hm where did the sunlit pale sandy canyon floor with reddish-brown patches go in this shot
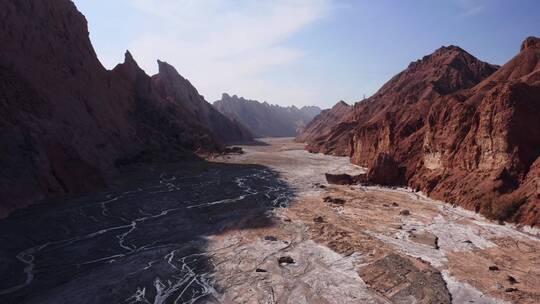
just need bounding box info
[211,139,540,303]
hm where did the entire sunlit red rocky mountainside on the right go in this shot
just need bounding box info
[309,38,540,225]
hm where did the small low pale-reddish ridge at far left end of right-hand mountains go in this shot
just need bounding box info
[296,101,352,154]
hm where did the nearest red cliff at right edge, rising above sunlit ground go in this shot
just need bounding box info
[409,38,540,225]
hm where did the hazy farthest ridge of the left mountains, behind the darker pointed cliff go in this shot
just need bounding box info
[152,61,253,142]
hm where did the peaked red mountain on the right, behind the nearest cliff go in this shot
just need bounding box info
[350,46,496,170]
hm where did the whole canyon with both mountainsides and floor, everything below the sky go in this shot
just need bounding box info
[0,0,540,304]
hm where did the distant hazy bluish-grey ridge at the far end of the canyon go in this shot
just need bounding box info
[214,94,321,137]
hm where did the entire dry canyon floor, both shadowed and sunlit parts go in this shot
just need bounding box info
[0,139,540,304]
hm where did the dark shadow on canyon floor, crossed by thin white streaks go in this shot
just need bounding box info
[0,162,294,303]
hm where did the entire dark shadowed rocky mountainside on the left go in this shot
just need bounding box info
[0,0,251,213]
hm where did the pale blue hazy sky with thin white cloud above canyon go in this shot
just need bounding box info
[74,0,540,107]
